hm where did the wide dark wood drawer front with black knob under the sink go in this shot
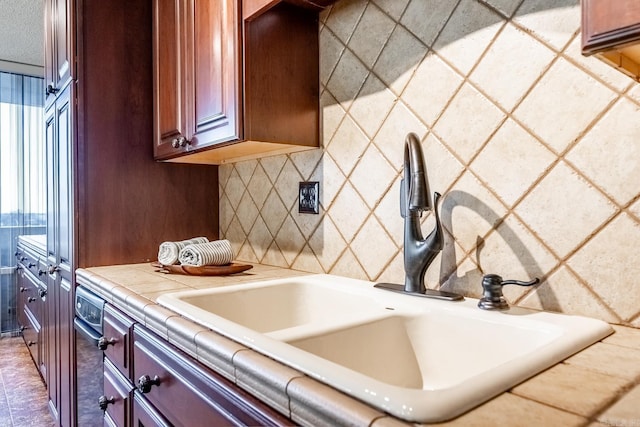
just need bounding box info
[133,325,290,427]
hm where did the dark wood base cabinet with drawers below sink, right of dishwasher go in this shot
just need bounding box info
[100,305,292,427]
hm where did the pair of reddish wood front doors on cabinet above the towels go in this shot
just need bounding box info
[153,0,241,159]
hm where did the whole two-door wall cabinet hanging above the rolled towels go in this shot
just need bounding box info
[153,0,322,164]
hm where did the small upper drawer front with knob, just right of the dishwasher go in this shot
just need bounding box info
[103,304,134,379]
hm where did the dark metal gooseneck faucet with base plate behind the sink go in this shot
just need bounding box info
[375,133,463,300]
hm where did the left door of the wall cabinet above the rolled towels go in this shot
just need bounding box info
[153,0,189,158]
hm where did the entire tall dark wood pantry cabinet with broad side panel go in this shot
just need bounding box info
[43,0,218,426]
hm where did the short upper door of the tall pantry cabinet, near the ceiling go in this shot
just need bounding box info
[44,0,75,104]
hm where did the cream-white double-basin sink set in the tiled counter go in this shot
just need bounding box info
[158,275,612,422]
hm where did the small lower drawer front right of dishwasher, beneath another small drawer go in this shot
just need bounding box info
[102,359,133,427]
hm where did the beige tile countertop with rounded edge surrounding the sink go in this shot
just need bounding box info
[77,264,640,427]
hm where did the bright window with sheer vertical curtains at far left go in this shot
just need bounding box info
[0,72,46,333]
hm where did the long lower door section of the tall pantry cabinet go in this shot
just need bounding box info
[44,85,74,426]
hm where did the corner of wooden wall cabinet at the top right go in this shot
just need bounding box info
[582,0,640,81]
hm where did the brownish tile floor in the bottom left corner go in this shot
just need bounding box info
[0,337,55,427]
